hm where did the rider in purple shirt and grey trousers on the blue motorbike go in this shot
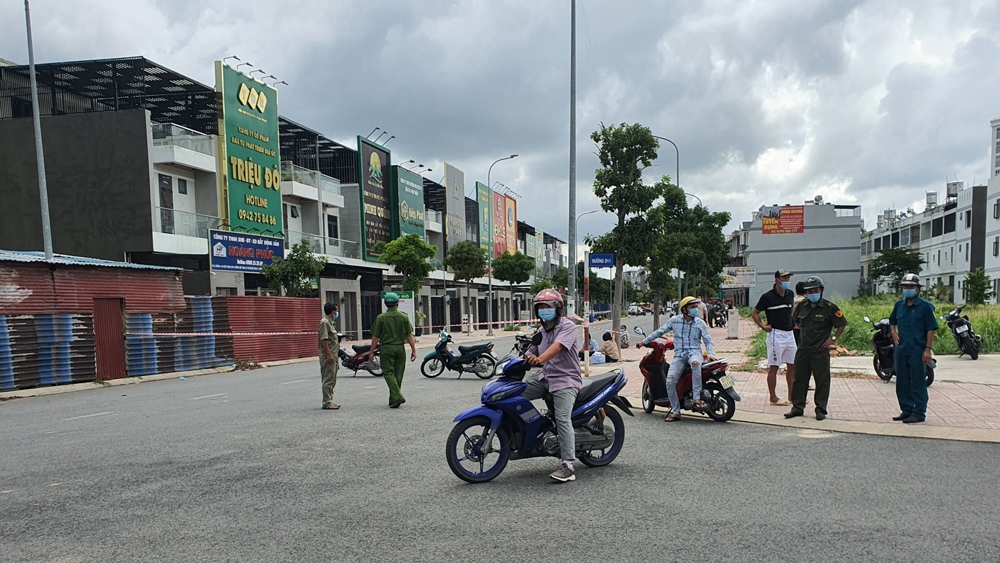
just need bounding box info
[524,289,583,483]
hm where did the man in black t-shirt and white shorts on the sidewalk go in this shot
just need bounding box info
[750,268,797,406]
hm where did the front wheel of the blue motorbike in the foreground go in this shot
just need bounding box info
[444,416,510,483]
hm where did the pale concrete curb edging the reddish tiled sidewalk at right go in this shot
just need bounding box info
[627,397,1000,444]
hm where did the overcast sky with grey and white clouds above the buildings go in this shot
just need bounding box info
[0,0,1000,251]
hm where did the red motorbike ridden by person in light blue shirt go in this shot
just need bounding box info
[635,327,741,422]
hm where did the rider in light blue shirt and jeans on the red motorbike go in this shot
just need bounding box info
[635,297,715,422]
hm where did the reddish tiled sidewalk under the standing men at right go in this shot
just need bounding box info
[621,322,1000,434]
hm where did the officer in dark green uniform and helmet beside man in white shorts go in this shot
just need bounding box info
[785,276,847,420]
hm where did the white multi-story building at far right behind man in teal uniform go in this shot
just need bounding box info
[861,182,987,303]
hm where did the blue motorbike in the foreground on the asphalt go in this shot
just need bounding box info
[445,358,634,483]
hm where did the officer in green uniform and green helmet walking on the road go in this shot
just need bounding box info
[372,293,417,409]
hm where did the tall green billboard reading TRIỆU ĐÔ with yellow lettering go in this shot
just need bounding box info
[215,61,284,237]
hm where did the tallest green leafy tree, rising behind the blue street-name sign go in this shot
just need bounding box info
[588,123,667,334]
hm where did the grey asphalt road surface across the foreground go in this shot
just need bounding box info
[0,330,1000,562]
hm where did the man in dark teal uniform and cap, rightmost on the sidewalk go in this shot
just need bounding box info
[889,274,938,424]
